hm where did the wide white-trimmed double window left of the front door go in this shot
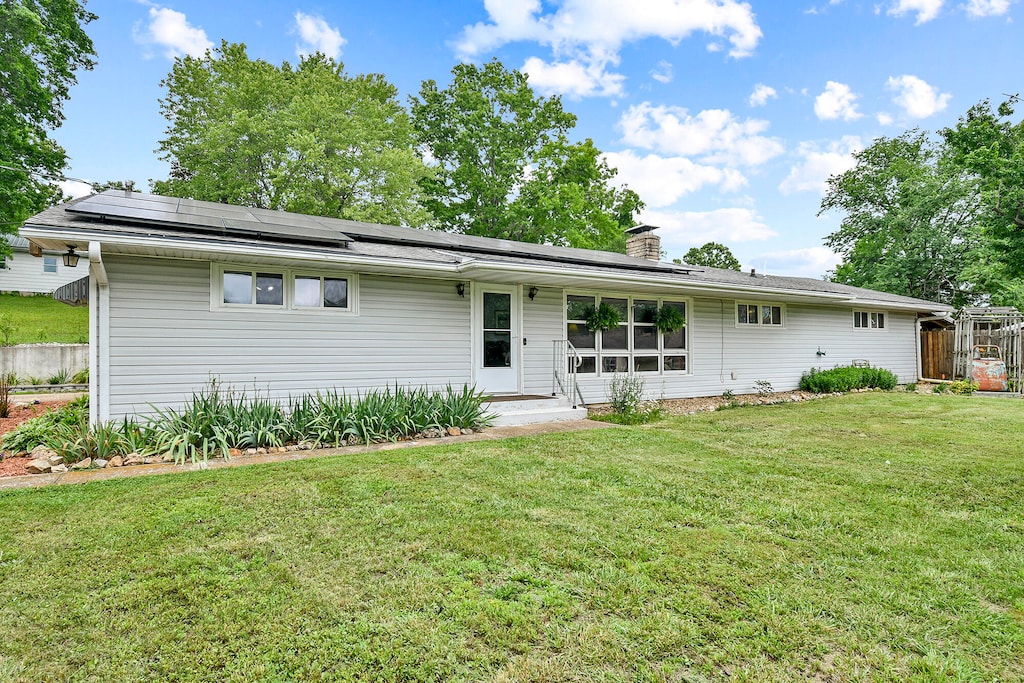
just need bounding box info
[210,265,355,312]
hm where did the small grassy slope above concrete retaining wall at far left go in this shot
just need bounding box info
[0,294,89,344]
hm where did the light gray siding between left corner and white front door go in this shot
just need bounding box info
[104,256,471,418]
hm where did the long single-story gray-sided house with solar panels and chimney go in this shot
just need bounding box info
[23,190,950,420]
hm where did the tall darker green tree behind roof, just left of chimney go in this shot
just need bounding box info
[411,59,643,251]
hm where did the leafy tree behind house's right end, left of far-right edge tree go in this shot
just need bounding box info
[819,130,982,306]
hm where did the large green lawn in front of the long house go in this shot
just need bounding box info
[0,393,1024,681]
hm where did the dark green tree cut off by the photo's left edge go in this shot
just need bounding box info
[0,0,96,258]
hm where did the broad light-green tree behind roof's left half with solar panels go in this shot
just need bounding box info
[154,42,430,225]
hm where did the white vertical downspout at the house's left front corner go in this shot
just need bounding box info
[89,242,111,425]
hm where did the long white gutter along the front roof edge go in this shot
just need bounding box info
[20,225,941,311]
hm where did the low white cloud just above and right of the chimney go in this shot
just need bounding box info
[640,208,778,256]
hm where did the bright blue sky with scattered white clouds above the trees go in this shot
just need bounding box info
[54,0,1022,278]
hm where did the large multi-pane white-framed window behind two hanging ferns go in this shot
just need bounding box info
[565,294,689,375]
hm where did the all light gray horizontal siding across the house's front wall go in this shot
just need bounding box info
[104,256,918,419]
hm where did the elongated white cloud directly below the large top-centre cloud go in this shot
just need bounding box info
[618,102,783,166]
